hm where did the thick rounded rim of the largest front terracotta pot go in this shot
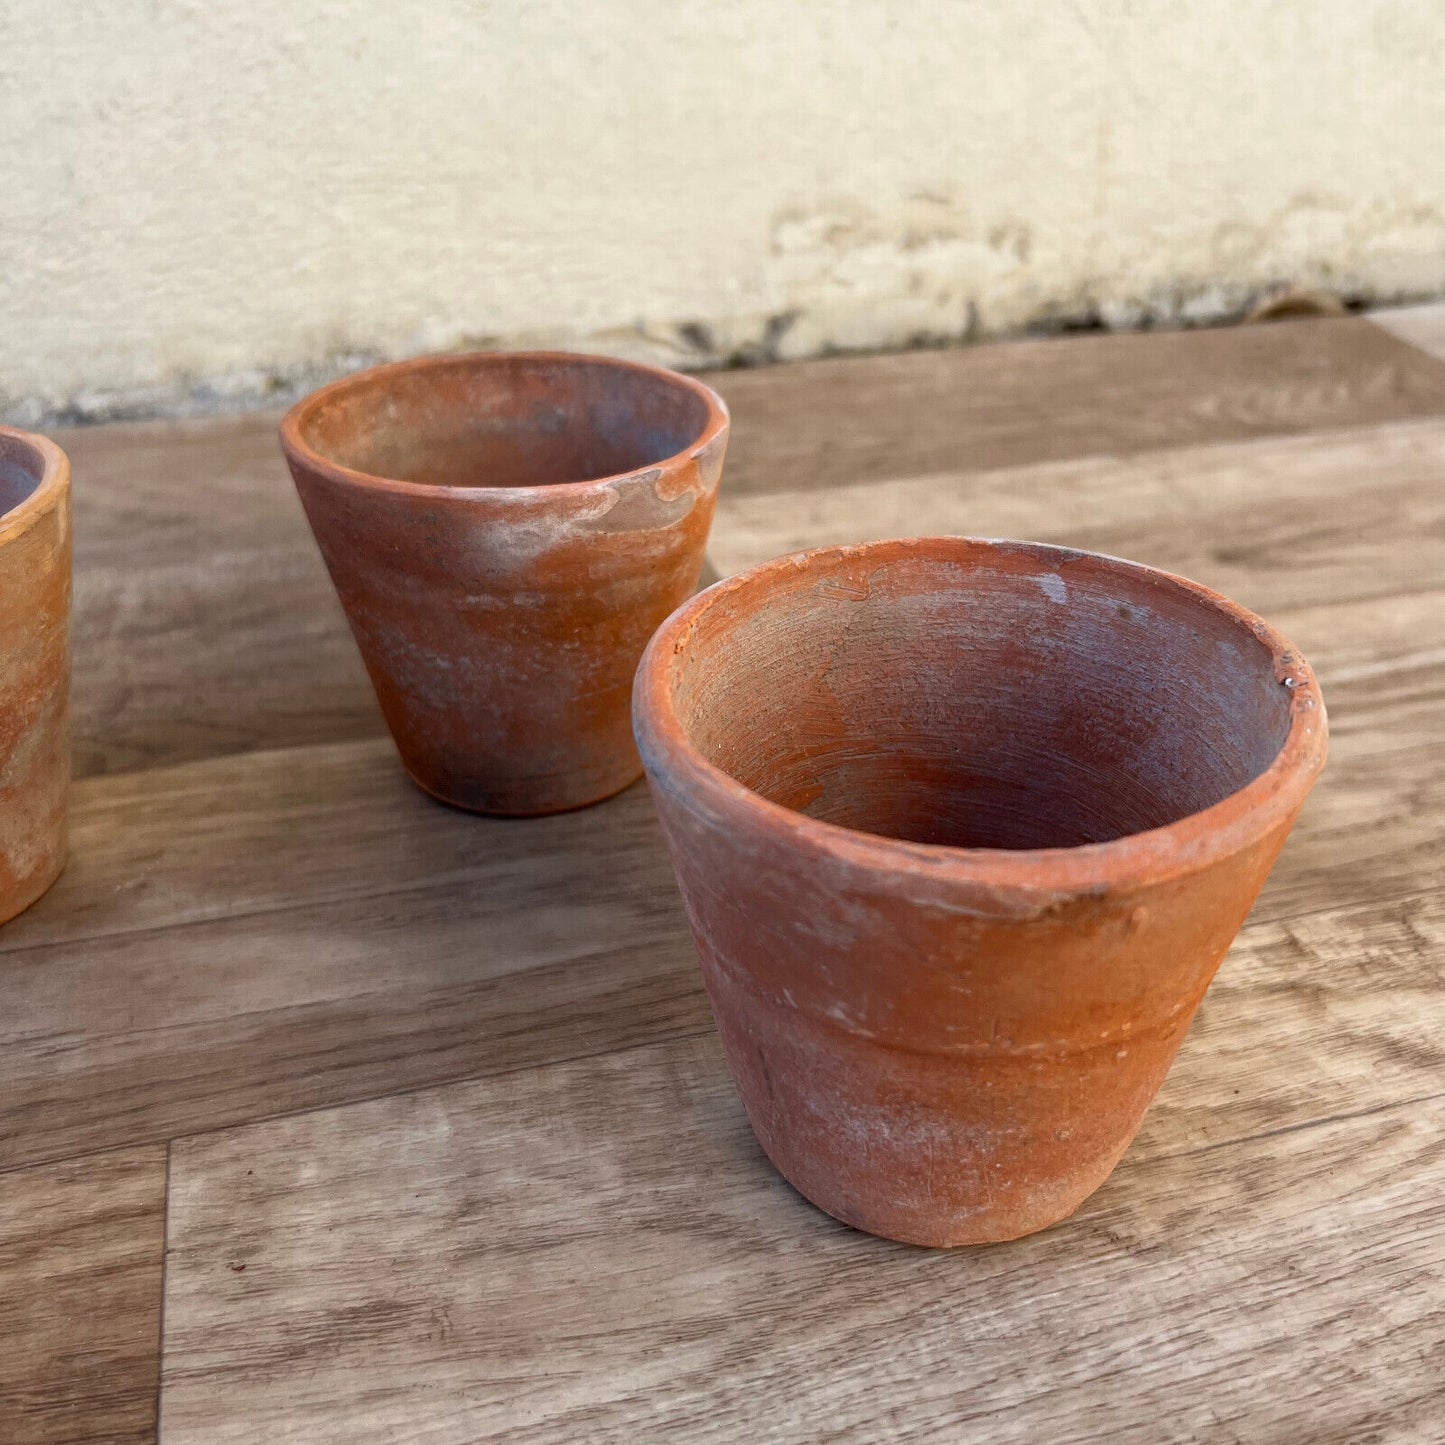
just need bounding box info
[633,536,1328,916]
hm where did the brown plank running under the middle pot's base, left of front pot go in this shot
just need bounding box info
[0,738,660,957]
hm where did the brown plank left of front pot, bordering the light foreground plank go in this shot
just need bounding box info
[0,849,711,1168]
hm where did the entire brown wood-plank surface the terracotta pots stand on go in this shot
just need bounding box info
[0,308,1445,1445]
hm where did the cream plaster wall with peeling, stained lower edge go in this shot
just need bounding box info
[0,0,1445,419]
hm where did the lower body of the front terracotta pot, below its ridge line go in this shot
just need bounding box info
[704,976,1173,1248]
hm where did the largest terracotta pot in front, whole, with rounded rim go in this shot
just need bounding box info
[634,538,1325,1244]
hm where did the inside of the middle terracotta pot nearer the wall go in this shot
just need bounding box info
[301,354,709,487]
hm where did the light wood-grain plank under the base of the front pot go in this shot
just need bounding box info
[163,1038,1445,1445]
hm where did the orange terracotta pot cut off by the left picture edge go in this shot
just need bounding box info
[0,426,71,923]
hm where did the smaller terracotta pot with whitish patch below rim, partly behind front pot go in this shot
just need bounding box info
[282,353,728,814]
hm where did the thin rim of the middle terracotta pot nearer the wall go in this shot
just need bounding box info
[280,351,730,500]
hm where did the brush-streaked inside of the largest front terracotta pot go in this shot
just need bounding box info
[669,539,1290,848]
